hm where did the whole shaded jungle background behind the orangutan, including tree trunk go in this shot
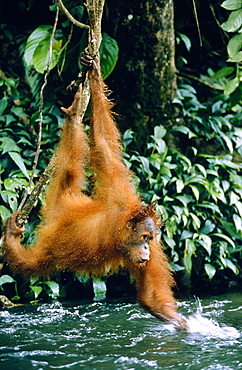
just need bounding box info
[0,0,242,301]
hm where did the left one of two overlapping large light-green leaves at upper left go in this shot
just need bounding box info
[24,25,51,66]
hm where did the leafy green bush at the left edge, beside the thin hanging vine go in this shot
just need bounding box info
[0,69,61,227]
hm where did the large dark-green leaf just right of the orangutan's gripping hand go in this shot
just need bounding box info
[99,33,119,80]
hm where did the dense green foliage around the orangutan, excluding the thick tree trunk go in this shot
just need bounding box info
[0,0,242,299]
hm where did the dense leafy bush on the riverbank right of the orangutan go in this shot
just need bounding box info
[124,85,242,285]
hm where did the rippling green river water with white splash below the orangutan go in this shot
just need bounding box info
[0,293,242,370]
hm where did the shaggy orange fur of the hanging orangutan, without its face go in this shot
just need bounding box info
[4,56,183,325]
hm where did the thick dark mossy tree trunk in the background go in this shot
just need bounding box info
[104,0,177,139]
